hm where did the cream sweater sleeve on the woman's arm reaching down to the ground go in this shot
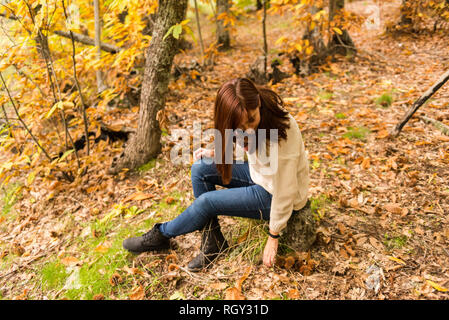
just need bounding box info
[270,155,299,232]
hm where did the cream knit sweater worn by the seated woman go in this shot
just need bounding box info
[236,114,309,232]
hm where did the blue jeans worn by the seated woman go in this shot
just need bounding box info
[159,158,272,238]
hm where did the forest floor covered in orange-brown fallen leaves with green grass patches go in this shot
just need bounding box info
[0,2,449,299]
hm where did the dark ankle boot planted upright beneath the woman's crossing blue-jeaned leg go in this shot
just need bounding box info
[187,218,229,272]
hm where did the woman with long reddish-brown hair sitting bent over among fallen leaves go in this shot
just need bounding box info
[123,78,309,271]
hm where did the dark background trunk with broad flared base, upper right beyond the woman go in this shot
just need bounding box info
[328,0,356,55]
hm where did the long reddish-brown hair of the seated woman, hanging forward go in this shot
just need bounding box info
[214,78,289,184]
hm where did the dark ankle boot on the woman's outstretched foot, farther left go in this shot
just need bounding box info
[123,223,170,254]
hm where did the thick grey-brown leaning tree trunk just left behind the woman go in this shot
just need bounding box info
[108,0,188,174]
